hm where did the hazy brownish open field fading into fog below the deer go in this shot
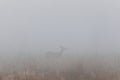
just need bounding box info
[0,53,120,80]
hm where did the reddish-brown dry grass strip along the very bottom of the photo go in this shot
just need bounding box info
[0,64,120,80]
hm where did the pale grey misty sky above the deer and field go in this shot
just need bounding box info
[0,0,120,53]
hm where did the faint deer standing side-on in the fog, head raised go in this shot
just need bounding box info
[45,46,66,58]
